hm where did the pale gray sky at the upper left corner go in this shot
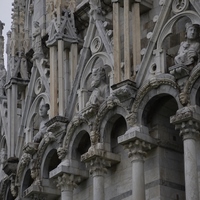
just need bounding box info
[0,0,13,68]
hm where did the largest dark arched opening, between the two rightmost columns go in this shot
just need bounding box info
[142,94,185,199]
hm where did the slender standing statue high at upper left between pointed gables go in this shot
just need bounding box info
[33,21,44,58]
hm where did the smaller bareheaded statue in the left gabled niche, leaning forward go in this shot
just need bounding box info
[33,104,50,143]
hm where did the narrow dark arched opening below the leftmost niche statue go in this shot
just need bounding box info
[43,149,61,179]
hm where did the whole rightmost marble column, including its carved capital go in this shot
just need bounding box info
[170,106,200,200]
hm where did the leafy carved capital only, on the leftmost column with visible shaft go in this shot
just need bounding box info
[57,173,81,192]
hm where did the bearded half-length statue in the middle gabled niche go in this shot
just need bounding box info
[86,67,110,106]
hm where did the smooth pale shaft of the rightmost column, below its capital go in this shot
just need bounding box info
[183,138,199,200]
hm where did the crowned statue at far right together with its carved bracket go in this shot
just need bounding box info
[169,22,200,79]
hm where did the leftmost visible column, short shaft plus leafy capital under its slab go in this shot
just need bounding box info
[57,173,79,200]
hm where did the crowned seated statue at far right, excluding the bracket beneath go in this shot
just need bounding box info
[174,22,200,67]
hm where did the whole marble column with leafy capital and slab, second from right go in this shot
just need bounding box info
[118,127,156,200]
